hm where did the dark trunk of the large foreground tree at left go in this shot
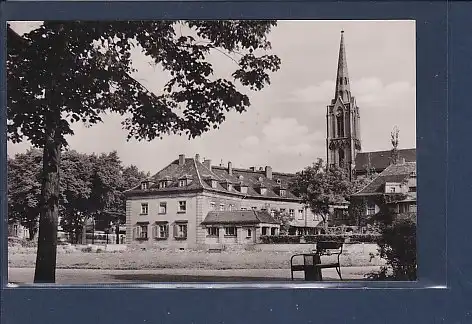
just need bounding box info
[34,129,61,283]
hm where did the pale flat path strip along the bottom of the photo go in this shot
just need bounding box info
[8,267,378,285]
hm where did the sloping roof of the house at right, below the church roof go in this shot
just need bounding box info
[354,162,416,196]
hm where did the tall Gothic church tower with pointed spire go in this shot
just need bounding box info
[326,31,361,178]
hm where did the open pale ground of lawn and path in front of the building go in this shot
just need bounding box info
[8,246,382,284]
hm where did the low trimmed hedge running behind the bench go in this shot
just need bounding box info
[261,234,380,244]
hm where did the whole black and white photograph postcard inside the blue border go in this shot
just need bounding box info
[6,20,418,285]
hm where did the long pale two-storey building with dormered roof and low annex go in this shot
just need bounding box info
[126,154,321,248]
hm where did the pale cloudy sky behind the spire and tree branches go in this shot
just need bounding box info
[7,20,416,173]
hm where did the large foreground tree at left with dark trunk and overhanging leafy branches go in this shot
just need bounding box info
[7,21,280,282]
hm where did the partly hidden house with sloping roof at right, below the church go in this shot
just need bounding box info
[352,160,417,224]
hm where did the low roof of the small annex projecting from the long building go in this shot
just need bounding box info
[202,210,280,225]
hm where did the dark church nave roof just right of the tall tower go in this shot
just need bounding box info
[355,148,416,173]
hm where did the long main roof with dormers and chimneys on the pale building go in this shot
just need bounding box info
[127,154,300,201]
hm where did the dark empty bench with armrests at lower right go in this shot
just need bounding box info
[290,241,344,281]
